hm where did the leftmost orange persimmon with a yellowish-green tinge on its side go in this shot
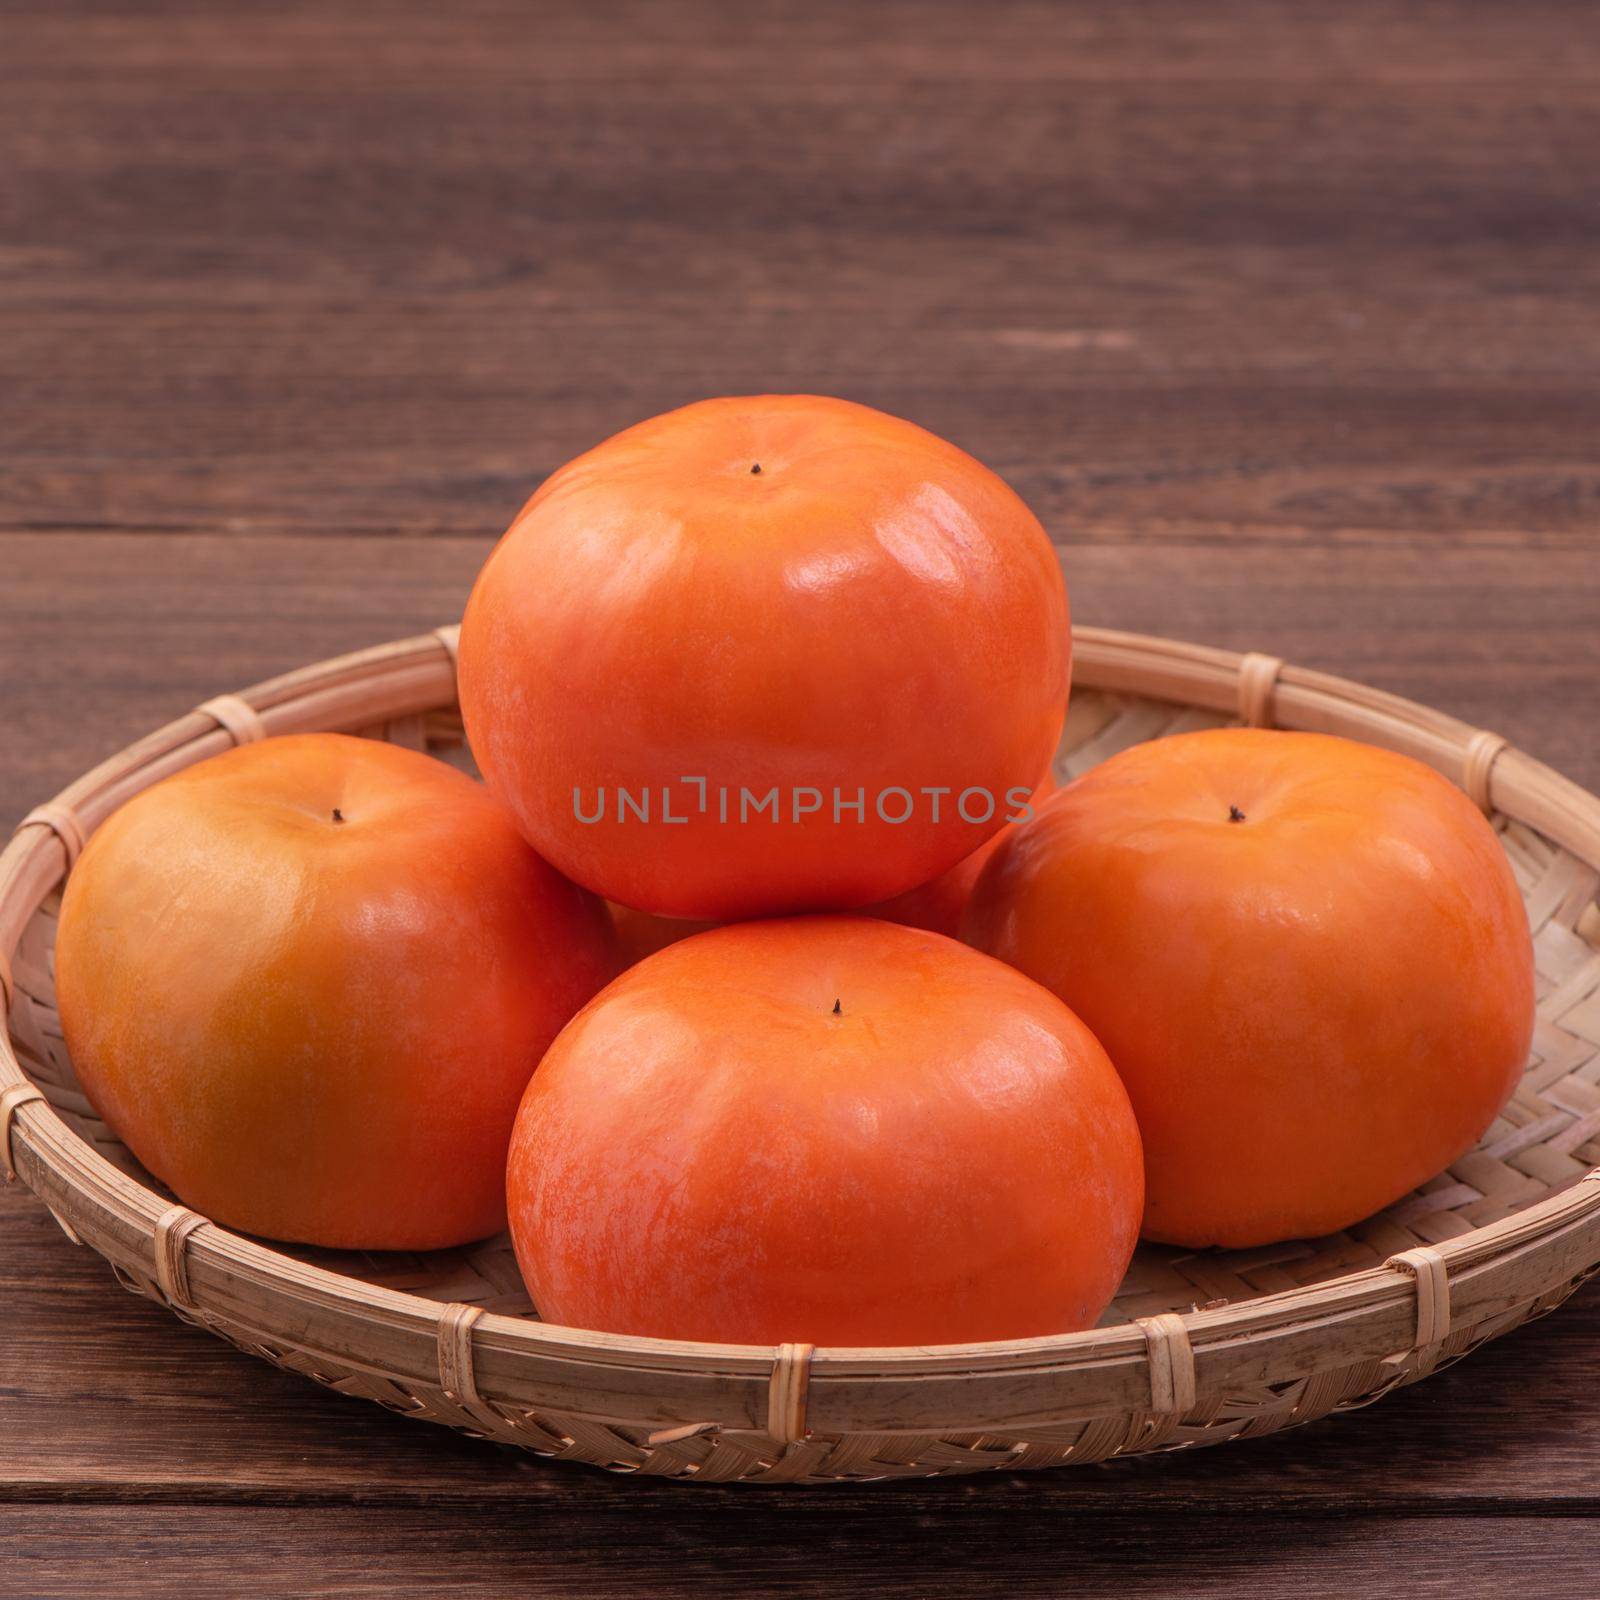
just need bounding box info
[56,734,614,1250]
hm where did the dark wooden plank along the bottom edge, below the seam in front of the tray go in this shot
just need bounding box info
[0,1491,1594,1600]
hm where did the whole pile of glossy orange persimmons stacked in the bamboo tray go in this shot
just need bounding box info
[56,397,1533,1344]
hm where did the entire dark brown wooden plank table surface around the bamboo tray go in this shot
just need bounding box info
[0,0,1600,1600]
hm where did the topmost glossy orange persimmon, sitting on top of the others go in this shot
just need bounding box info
[461,395,1070,920]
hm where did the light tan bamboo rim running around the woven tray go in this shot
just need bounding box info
[0,627,1600,1432]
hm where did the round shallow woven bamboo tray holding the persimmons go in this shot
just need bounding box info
[0,629,1600,1483]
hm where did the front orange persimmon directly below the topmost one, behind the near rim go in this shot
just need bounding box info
[507,917,1142,1346]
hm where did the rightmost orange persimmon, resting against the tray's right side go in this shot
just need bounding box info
[963,730,1534,1246]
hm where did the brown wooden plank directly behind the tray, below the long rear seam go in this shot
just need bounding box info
[0,528,1600,838]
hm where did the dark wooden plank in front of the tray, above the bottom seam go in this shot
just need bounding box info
[0,1194,1600,1510]
